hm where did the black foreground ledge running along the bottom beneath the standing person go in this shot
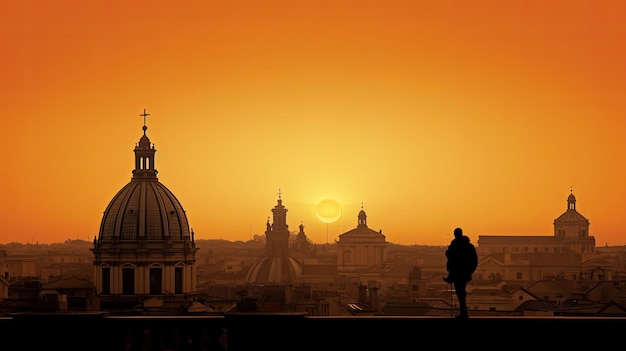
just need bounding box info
[0,313,626,351]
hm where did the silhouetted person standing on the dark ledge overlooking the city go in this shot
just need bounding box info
[443,228,478,318]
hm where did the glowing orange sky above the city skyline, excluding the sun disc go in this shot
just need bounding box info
[0,0,626,246]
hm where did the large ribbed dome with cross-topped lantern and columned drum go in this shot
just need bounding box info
[92,110,198,308]
